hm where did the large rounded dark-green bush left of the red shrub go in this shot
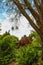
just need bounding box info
[0,35,19,65]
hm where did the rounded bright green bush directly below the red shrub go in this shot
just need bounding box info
[16,42,41,65]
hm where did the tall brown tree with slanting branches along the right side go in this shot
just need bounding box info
[4,0,43,60]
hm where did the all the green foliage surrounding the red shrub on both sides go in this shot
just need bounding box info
[0,32,43,65]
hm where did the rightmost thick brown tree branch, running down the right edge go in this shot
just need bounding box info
[34,0,43,27]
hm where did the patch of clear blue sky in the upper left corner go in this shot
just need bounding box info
[0,0,33,21]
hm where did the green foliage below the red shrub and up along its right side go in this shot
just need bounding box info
[16,32,41,65]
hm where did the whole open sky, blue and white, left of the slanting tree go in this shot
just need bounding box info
[0,0,33,38]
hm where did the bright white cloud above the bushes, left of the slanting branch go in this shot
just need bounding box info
[0,16,33,38]
